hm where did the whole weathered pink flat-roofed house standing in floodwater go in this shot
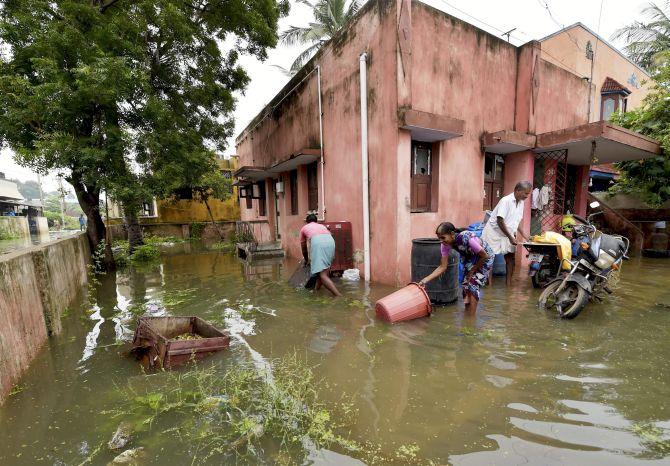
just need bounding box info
[236,0,660,285]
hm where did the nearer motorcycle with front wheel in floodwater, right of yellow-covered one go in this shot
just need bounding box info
[538,202,630,319]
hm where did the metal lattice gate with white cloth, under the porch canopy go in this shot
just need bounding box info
[531,149,568,235]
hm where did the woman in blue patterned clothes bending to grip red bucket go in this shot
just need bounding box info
[419,222,495,313]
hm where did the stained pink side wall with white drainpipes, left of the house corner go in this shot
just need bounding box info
[237,0,397,280]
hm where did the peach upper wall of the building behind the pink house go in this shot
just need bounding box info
[542,25,652,122]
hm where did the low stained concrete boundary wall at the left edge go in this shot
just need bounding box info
[0,233,90,402]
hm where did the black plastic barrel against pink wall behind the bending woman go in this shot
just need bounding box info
[412,238,459,304]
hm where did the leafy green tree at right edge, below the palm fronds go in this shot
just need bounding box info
[612,51,670,206]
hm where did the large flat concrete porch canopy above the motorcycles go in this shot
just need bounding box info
[534,121,661,165]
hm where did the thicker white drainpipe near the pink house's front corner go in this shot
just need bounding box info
[358,53,370,282]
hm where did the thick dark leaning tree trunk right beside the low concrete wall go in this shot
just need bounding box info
[68,174,115,271]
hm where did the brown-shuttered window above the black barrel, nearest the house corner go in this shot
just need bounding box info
[411,141,439,212]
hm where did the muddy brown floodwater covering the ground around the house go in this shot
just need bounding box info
[0,244,670,465]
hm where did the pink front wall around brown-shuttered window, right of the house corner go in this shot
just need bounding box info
[410,2,517,240]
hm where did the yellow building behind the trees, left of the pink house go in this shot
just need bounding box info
[108,156,240,237]
